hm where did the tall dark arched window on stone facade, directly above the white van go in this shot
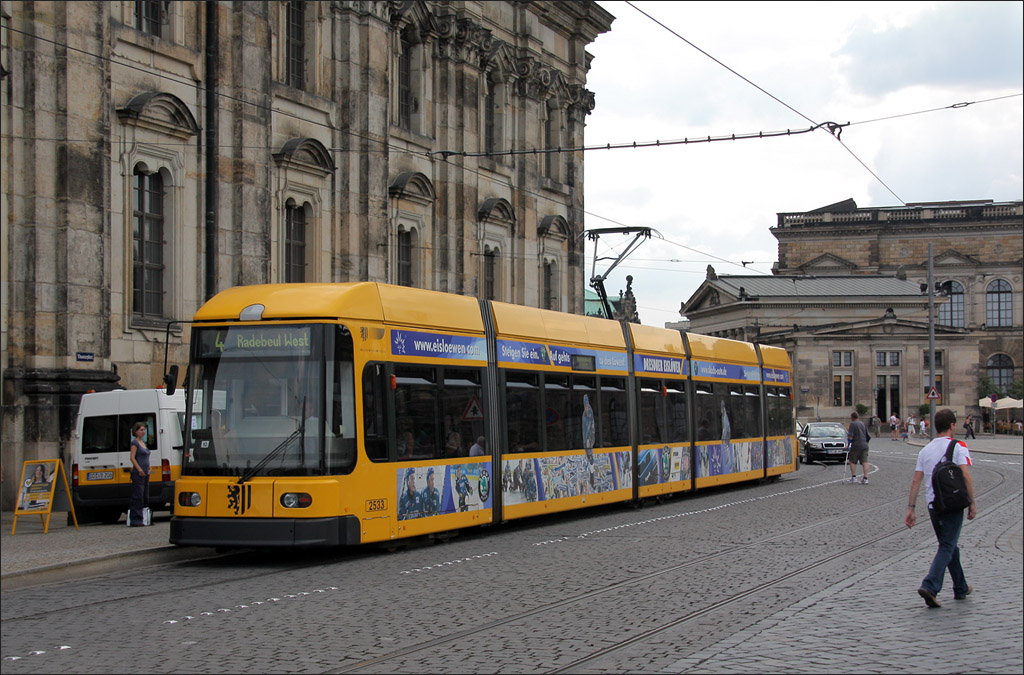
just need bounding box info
[132,164,165,319]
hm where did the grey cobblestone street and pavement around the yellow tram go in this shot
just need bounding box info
[2,437,1024,675]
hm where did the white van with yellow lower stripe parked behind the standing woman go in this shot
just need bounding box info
[69,389,185,523]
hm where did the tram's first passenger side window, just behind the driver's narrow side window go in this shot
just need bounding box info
[394,365,440,460]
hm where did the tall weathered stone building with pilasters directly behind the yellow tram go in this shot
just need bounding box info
[0,0,613,508]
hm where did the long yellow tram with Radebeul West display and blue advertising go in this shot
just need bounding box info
[170,283,797,547]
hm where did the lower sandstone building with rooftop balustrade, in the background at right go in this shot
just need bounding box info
[680,200,1024,421]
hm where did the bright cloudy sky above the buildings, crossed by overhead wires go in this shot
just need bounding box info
[585,0,1024,326]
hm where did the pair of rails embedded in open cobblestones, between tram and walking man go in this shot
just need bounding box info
[325,469,1007,674]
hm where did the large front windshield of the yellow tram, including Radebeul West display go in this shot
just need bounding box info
[182,324,354,478]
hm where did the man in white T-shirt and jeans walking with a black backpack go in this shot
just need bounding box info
[905,408,978,607]
